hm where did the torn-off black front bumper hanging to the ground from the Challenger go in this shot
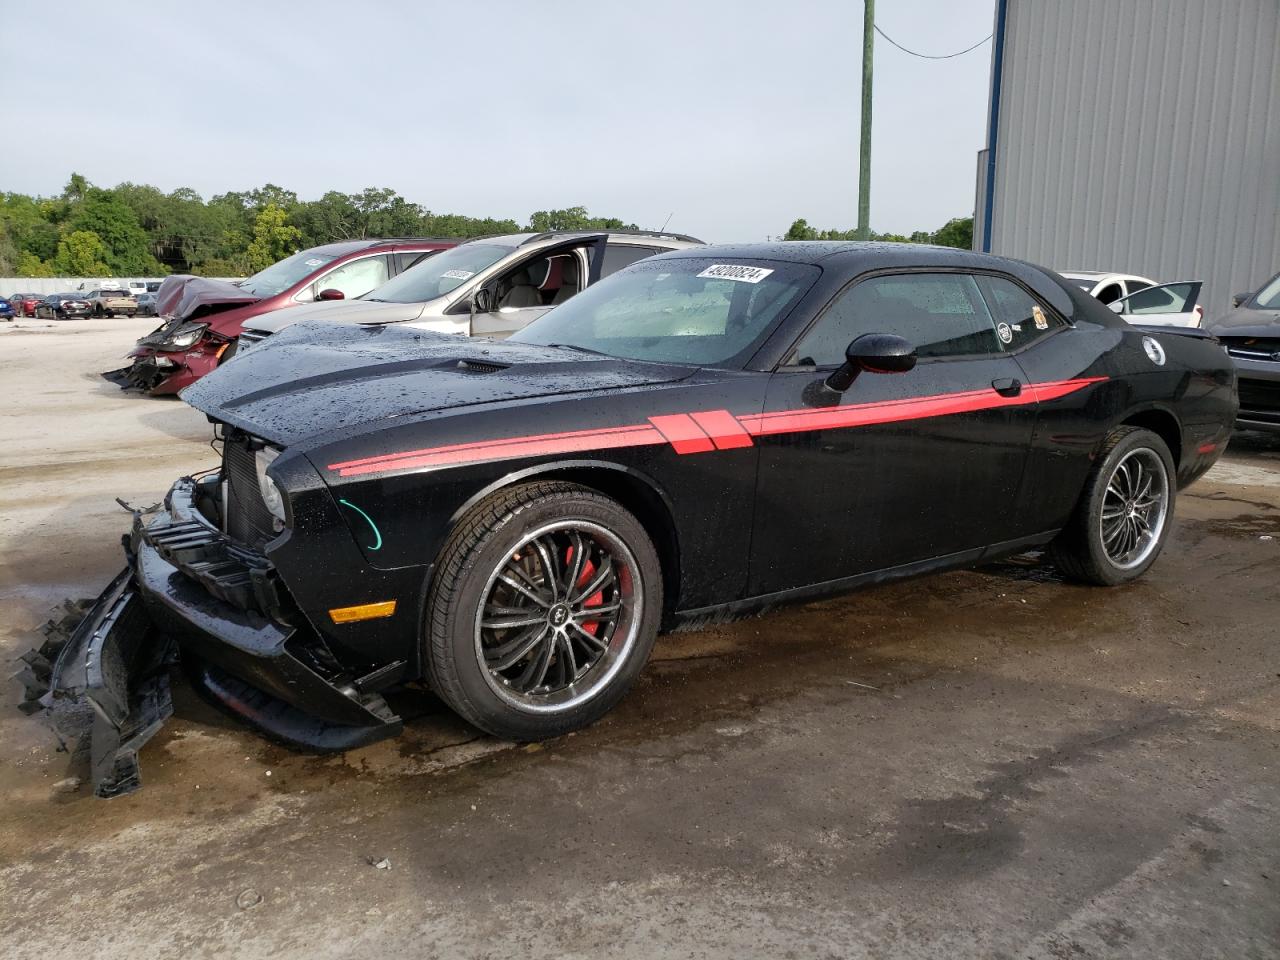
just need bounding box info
[19,477,402,796]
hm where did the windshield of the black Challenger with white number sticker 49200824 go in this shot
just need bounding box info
[511,257,822,366]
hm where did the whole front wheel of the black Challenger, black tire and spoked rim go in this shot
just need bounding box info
[424,481,662,741]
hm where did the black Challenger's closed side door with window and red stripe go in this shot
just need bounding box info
[751,273,1036,594]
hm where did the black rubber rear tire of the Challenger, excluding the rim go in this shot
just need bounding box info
[1048,426,1178,586]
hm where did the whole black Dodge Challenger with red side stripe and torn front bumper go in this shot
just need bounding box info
[28,243,1236,795]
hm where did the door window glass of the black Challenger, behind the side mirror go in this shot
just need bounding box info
[792,274,1001,366]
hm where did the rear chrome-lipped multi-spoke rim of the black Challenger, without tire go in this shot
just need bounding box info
[1098,447,1169,570]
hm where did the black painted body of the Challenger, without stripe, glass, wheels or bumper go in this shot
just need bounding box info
[175,244,1233,680]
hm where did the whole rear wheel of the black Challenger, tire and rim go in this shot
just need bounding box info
[1050,426,1178,586]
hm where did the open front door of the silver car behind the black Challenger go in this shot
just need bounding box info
[471,233,608,339]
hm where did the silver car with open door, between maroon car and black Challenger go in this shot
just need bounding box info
[238,230,701,351]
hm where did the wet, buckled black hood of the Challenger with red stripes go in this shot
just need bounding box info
[182,323,694,447]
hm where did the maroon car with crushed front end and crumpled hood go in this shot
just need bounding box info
[102,239,457,397]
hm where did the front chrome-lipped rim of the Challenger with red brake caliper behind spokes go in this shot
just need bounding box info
[475,520,644,713]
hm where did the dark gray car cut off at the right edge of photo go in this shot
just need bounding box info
[1208,274,1280,431]
